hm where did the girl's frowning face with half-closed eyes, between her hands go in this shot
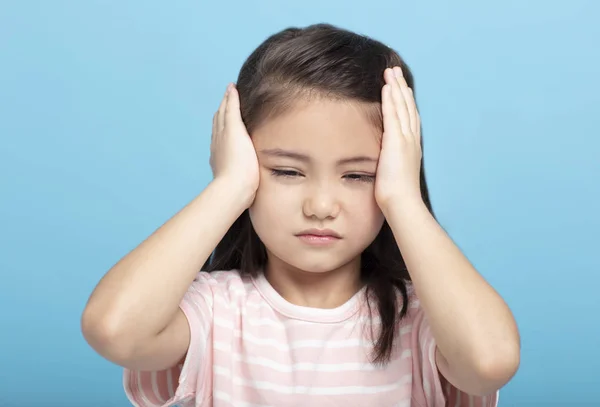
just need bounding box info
[250,100,384,273]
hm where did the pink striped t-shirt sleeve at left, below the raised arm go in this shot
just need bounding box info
[123,272,214,407]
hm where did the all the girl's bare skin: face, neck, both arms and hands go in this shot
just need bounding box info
[82,68,520,394]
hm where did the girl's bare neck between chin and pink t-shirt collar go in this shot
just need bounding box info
[264,256,362,308]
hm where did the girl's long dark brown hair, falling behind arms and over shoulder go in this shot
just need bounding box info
[203,24,435,364]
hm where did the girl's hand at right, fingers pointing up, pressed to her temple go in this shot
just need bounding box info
[375,67,423,212]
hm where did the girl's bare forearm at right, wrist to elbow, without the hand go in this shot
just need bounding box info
[384,202,519,393]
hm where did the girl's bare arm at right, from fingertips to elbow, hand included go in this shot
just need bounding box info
[375,67,520,395]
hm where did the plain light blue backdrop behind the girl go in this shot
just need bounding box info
[0,0,600,407]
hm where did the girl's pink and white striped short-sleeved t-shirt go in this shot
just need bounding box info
[124,270,498,407]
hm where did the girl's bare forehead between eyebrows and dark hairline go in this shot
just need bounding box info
[252,100,381,158]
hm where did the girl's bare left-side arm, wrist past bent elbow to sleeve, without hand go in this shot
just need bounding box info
[81,180,248,370]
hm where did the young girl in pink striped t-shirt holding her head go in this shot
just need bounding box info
[82,24,520,407]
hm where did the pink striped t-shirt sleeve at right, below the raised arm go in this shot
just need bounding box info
[410,300,499,407]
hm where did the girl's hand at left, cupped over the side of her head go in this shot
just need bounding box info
[210,84,260,206]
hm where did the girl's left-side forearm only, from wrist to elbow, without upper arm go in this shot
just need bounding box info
[82,182,244,350]
